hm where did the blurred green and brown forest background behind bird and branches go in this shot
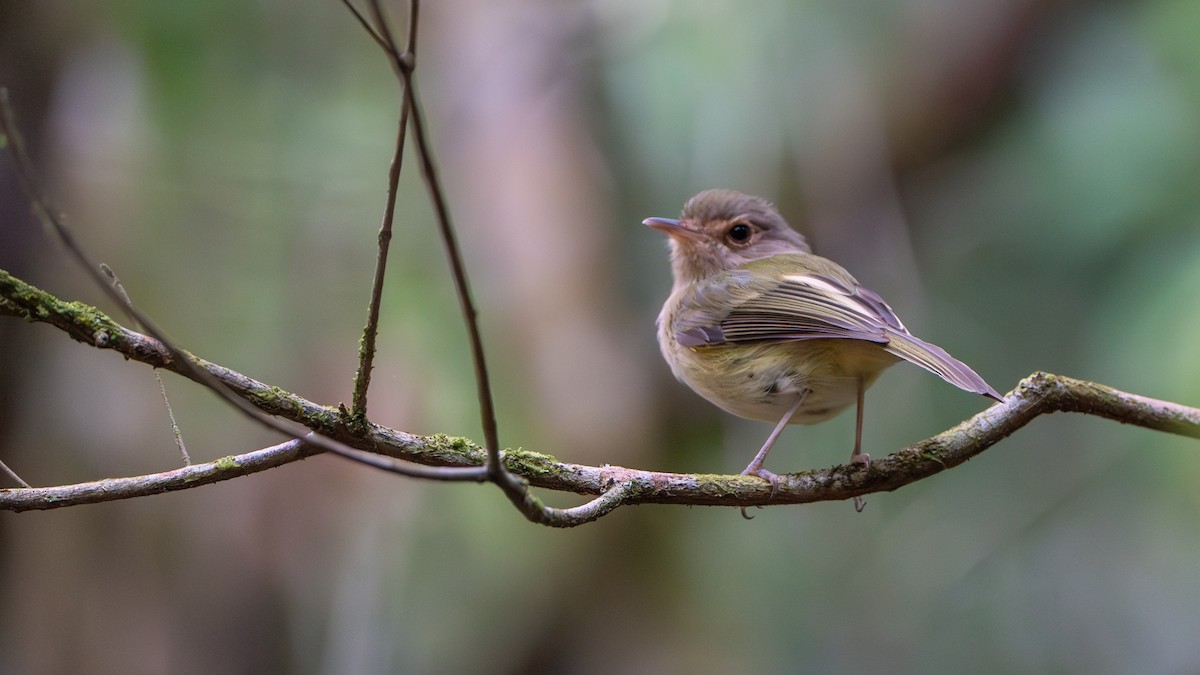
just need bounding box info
[0,0,1200,674]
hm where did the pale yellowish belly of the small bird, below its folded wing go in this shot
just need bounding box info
[667,340,898,424]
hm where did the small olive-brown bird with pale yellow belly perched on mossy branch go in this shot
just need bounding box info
[642,190,1004,504]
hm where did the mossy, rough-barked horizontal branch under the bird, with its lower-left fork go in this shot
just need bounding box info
[0,265,1200,527]
